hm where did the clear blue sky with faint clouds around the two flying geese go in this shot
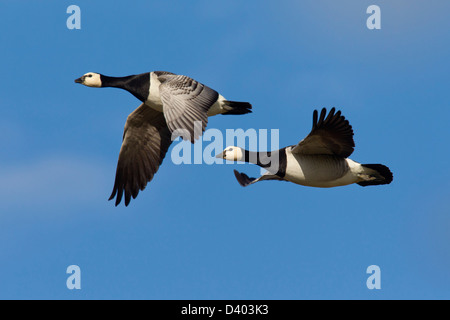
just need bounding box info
[0,0,450,299]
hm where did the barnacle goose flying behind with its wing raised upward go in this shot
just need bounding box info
[216,108,393,188]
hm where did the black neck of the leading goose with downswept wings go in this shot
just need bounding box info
[100,72,150,102]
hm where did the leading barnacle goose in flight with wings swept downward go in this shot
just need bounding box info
[75,71,252,206]
